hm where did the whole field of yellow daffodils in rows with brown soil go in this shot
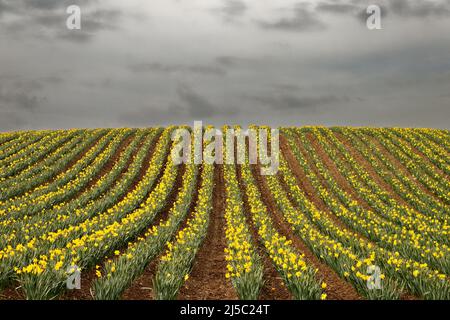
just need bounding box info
[0,126,450,300]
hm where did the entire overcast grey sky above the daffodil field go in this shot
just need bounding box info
[0,0,450,131]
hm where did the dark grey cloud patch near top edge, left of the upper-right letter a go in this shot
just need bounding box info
[257,5,325,32]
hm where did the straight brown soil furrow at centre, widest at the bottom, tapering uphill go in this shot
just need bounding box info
[178,165,237,300]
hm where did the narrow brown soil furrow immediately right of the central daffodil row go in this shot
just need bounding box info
[236,165,292,300]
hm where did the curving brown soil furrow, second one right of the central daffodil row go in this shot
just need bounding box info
[252,166,361,300]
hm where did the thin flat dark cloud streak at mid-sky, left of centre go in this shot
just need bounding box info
[128,62,226,76]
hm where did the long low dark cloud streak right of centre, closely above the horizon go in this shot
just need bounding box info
[249,93,350,111]
